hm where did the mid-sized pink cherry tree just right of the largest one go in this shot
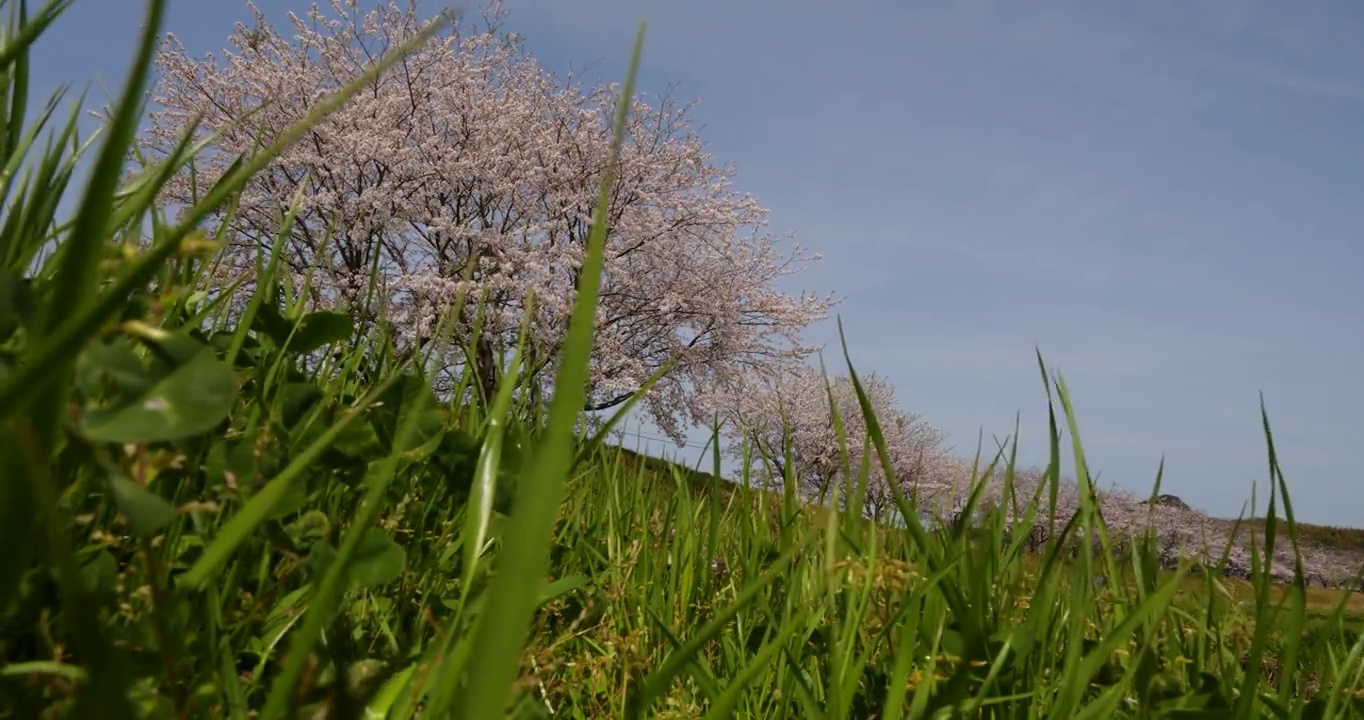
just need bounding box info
[712,363,968,517]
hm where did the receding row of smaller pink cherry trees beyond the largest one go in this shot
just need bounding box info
[712,364,1364,580]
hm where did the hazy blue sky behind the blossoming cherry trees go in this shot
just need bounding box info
[35,0,1364,526]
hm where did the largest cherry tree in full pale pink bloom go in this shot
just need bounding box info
[143,0,835,439]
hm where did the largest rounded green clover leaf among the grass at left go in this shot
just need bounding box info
[80,338,237,443]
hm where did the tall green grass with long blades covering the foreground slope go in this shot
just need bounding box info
[0,0,1364,719]
